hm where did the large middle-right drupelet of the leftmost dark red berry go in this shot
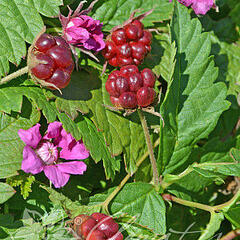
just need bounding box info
[47,46,73,68]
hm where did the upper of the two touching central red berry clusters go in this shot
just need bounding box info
[102,19,152,67]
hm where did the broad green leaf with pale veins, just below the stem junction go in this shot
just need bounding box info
[90,182,166,234]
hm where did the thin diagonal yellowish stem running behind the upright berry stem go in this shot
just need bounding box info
[102,139,160,212]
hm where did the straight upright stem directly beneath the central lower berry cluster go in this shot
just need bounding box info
[138,109,159,186]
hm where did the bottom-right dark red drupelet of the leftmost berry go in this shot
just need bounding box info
[47,68,71,89]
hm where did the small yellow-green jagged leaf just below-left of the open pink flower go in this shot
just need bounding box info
[7,172,35,199]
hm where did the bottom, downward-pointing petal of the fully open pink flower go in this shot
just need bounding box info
[43,165,70,188]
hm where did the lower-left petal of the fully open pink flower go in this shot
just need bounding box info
[21,146,44,174]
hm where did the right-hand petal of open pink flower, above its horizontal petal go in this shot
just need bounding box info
[60,140,89,160]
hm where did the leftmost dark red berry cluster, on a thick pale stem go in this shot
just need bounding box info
[30,33,74,89]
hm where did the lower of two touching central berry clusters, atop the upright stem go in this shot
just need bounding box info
[105,65,155,108]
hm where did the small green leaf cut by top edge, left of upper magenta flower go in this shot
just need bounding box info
[31,0,63,17]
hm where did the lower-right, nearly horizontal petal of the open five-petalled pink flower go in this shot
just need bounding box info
[56,161,87,175]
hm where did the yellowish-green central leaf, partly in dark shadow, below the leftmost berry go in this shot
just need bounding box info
[52,68,146,172]
